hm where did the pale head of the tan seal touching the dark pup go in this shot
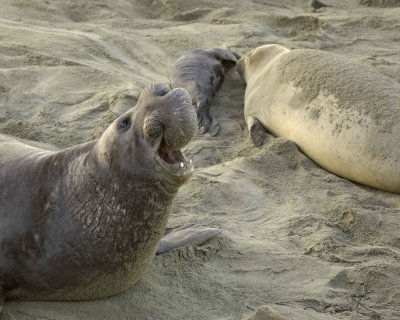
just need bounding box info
[236,44,289,82]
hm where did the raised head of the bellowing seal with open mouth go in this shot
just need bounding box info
[96,83,197,187]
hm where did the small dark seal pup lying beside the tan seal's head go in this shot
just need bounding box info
[171,48,240,136]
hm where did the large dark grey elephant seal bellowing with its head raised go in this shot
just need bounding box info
[0,84,219,312]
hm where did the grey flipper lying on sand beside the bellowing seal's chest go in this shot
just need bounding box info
[157,224,222,254]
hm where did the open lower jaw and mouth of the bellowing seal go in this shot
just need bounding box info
[156,139,194,182]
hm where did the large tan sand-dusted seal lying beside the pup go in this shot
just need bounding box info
[238,44,400,193]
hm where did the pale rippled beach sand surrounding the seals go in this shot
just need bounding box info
[0,0,400,320]
